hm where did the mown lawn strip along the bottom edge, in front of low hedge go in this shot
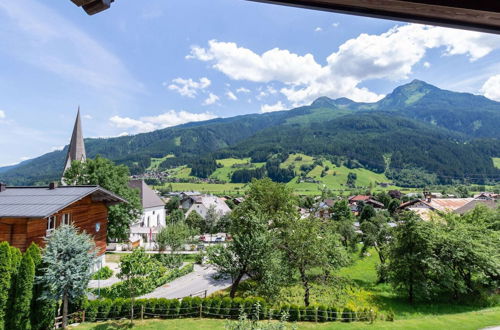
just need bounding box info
[75,307,500,330]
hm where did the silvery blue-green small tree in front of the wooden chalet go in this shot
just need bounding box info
[40,225,96,328]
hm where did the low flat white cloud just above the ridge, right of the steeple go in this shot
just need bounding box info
[109,110,217,136]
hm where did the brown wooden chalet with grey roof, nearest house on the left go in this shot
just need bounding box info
[0,183,126,268]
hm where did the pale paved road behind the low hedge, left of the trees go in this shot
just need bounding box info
[140,265,231,299]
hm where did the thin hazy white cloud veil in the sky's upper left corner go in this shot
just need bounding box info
[0,0,144,94]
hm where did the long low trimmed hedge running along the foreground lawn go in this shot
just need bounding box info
[85,297,375,322]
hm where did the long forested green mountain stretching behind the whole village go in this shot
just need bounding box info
[0,80,500,184]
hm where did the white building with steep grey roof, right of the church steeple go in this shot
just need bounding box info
[129,180,166,249]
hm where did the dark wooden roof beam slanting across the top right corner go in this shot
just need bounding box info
[248,0,500,34]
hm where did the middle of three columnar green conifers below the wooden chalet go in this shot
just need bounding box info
[9,253,35,330]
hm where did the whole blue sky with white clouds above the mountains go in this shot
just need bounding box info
[0,0,500,165]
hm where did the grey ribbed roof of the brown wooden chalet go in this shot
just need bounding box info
[0,186,127,218]
